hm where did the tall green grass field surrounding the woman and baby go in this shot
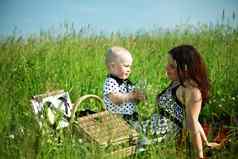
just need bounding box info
[0,25,238,159]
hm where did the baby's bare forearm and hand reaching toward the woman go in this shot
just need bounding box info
[109,90,145,105]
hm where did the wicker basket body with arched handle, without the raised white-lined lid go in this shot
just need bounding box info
[71,95,139,157]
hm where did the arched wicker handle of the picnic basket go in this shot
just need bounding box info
[70,94,104,123]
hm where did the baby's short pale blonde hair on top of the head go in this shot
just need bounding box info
[105,46,131,66]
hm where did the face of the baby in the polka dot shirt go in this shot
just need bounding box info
[110,55,133,80]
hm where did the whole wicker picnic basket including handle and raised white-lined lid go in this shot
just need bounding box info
[31,90,139,158]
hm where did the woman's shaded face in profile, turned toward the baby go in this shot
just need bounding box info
[165,54,178,81]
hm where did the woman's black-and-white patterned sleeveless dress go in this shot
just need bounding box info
[151,82,185,138]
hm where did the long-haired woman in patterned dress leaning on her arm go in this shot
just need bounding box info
[152,45,218,158]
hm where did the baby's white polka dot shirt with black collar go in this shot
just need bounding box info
[103,75,135,115]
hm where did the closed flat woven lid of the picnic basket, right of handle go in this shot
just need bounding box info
[78,111,138,146]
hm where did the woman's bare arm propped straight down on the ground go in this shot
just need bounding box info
[185,87,207,158]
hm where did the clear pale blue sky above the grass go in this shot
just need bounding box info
[0,0,238,35]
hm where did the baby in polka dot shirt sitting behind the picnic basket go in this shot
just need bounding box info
[103,47,145,123]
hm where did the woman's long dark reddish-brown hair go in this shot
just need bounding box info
[169,45,210,105]
